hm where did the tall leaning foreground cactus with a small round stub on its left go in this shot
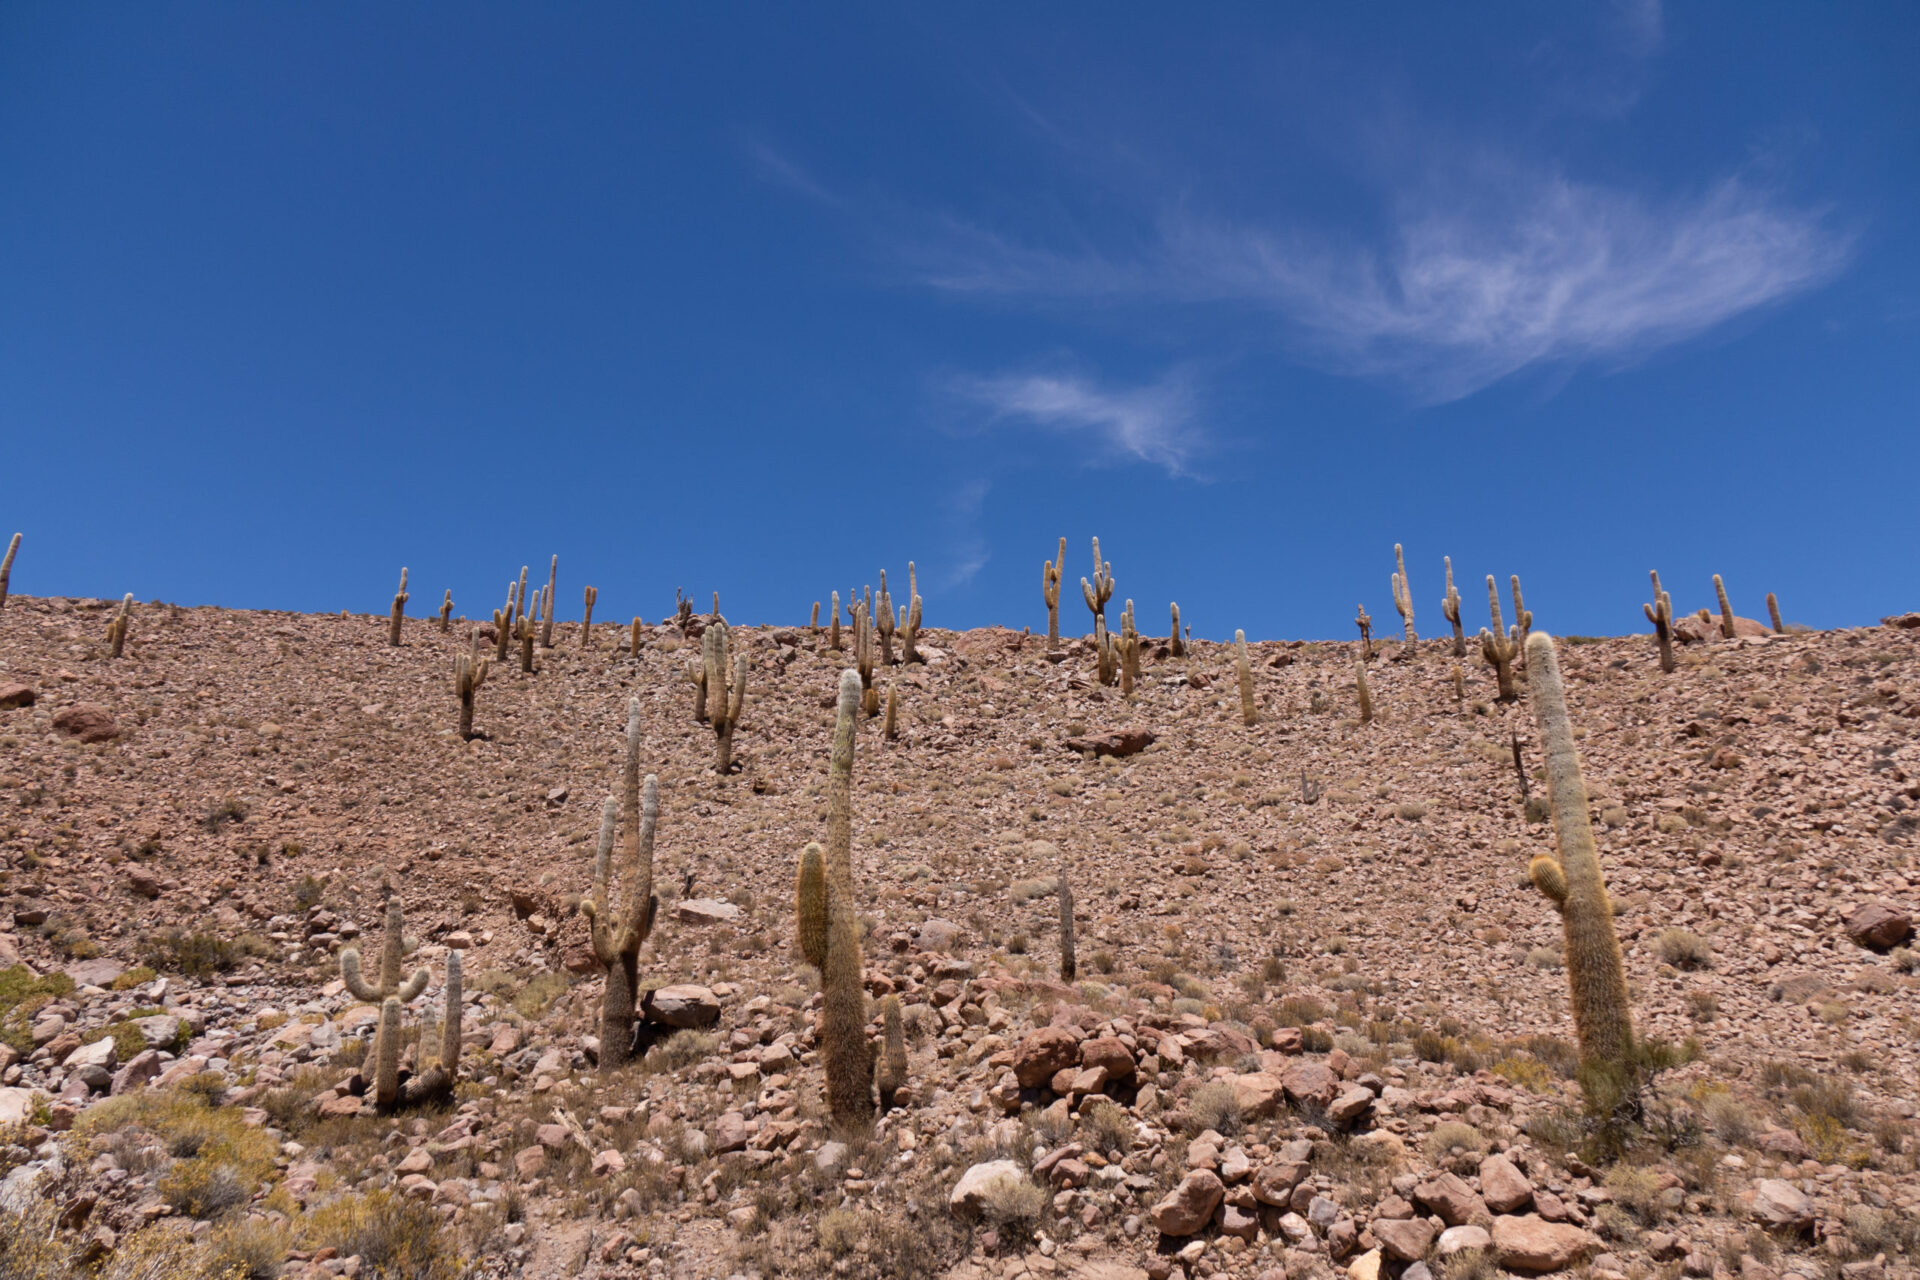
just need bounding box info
[1526,631,1638,1113]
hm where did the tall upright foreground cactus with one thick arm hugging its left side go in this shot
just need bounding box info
[797,670,874,1132]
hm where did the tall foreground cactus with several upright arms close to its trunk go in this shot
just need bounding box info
[580,697,660,1071]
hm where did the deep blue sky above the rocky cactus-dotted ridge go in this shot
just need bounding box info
[0,2,1920,637]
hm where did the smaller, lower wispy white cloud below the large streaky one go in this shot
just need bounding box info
[956,372,1200,476]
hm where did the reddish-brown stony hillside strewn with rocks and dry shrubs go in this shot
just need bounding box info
[0,597,1920,1280]
